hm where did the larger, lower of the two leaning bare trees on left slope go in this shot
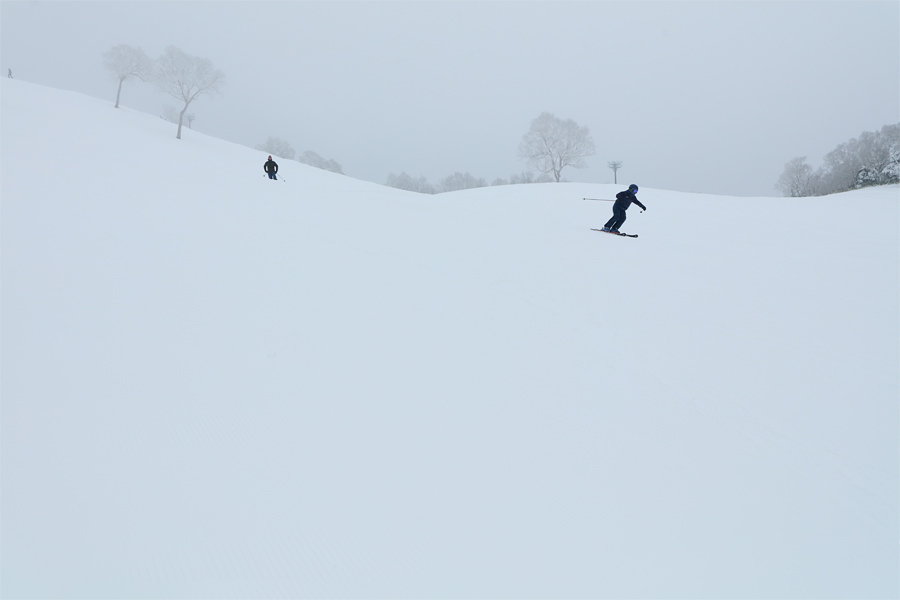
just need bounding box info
[155,46,225,140]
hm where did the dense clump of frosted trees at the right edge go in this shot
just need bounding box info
[775,123,900,198]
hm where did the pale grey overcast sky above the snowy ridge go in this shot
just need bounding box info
[0,0,900,196]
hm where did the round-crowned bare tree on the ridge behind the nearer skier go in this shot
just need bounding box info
[519,112,596,182]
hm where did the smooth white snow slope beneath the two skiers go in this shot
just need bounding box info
[0,80,900,598]
